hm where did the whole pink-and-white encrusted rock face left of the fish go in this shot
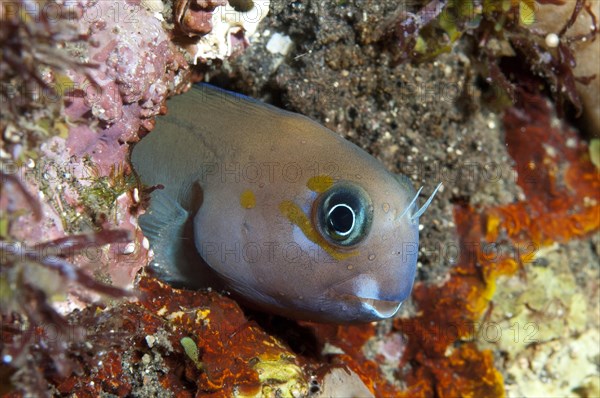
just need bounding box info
[0,0,189,304]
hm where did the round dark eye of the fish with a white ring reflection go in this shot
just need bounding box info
[316,182,373,246]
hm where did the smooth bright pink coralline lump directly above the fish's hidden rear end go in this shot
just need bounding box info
[66,1,187,173]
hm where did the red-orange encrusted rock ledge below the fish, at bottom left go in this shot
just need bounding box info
[36,277,306,397]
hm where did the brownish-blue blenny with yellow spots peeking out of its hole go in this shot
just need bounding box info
[131,85,441,323]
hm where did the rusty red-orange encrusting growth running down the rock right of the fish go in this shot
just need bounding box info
[394,91,600,397]
